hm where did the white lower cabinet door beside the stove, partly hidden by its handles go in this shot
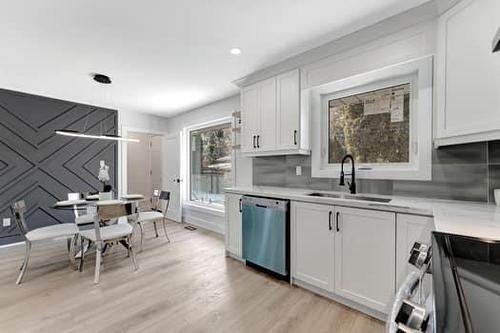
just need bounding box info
[396,214,434,289]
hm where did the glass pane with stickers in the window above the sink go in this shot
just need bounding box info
[328,83,411,164]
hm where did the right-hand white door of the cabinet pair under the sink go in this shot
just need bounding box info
[335,207,396,312]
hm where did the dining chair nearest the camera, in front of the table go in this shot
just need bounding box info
[76,204,138,284]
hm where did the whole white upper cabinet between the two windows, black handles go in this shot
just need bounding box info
[241,69,309,156]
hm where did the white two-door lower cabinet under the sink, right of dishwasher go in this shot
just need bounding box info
[291,202,396,312]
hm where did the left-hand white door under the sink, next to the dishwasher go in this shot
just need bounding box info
[291,202,334,292]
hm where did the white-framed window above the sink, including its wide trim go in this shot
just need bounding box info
[303,57,432,180]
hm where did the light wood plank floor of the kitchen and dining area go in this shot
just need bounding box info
[0,222,384,333]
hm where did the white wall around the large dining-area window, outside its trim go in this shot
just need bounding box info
[166,95,252,233]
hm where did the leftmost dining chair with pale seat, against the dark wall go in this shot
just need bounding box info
[11,200,78,284]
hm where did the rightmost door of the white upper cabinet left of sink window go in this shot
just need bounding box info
[277,69,300,149]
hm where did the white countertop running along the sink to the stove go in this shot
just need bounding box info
[226,186,500,240]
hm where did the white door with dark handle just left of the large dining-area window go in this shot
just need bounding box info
[163,134,182,222]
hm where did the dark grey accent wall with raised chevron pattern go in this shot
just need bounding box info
[0,89,118,245]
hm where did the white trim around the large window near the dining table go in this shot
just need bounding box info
[183,117,236,212]
